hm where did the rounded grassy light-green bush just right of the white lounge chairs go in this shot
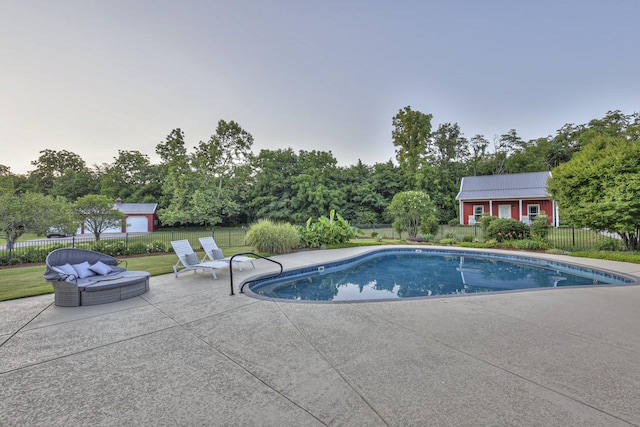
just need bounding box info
[246,220,301,254]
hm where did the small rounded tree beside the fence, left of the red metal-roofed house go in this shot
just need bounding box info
[388,191,437,238]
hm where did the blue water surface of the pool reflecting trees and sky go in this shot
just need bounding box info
[252,252,620,301]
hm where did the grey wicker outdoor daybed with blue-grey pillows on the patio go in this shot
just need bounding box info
[44,248,151,307]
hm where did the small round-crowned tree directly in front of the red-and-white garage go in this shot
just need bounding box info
[74,194,124,240]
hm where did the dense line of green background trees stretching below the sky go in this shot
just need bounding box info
[0,106,640,251]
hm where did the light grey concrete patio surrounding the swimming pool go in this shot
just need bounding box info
[0,248,640,426]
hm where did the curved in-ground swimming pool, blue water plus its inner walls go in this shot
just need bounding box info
[250,250,632,301]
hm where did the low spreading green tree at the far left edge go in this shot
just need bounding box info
[0,193,66,258]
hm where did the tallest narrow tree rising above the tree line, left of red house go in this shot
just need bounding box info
[391,106,433,189]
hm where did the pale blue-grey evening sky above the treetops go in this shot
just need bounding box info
[0,0,640,173]
